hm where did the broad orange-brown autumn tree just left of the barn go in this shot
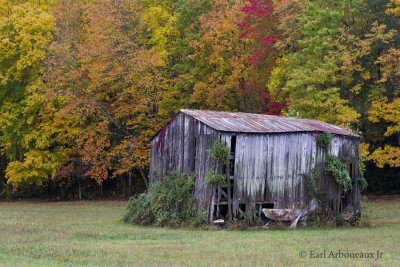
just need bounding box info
[44,1,170,191]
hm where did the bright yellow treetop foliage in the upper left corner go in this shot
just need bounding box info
[0,3,55,85]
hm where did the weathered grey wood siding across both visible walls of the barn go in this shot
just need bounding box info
[150,113,360,219]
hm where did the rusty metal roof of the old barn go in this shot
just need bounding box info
[181,109,359,137]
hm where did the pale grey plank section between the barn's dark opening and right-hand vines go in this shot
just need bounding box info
[234,133,315,208]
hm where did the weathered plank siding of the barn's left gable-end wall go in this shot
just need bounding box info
[150,113,219,215]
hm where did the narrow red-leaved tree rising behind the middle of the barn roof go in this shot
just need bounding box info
[238,0,287,115]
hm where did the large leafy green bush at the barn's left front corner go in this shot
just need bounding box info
[123,173,206,227]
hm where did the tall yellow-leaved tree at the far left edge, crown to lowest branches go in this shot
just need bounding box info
[0,3,60,186]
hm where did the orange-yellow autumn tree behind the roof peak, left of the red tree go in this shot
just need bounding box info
[191,0,263,112]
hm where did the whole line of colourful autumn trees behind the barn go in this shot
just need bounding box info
[0,0,400,197]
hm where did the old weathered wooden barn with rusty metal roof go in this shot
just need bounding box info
[150,110,360,223]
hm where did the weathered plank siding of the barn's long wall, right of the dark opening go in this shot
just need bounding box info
[228,133,359,216]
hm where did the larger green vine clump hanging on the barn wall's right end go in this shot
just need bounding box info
[325,155,352,192]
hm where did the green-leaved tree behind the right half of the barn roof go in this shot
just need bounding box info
[271,0,359,123]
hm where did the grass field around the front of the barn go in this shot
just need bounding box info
[0,197,400,266]
